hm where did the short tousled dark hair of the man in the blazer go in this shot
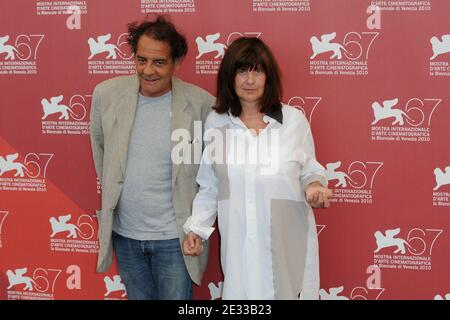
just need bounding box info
[127,15,188,61]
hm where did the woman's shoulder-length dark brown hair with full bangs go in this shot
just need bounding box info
[213,37,282,117]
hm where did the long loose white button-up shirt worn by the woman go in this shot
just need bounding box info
[184,105,327,299]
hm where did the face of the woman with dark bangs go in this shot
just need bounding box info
[234,66,266,105]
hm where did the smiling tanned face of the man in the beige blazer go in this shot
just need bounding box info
[134,34,179,97]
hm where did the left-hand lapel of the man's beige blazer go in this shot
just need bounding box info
[117,75,139,176]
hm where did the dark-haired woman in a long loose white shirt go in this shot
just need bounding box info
[183,38,332,299]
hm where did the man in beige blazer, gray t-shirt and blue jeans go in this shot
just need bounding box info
[91,16,215,299]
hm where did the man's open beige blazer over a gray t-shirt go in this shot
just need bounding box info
[91,75,215,284]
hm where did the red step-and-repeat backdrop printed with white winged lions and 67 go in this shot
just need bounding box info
[0,0,450,299]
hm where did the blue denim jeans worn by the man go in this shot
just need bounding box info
[112,232,192,300]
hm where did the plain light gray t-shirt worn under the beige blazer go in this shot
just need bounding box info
[113,92,178,240]
